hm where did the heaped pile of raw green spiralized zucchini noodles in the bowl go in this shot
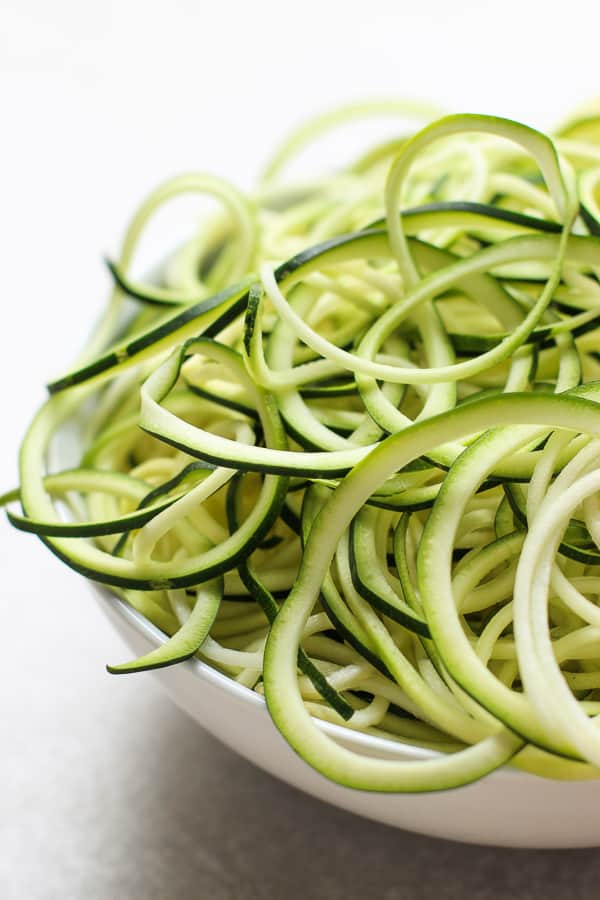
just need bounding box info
[2,102,600,791]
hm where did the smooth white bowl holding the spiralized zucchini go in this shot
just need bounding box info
[94,586,600,847]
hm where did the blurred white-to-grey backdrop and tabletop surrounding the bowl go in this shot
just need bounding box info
[0,0,600,900]
